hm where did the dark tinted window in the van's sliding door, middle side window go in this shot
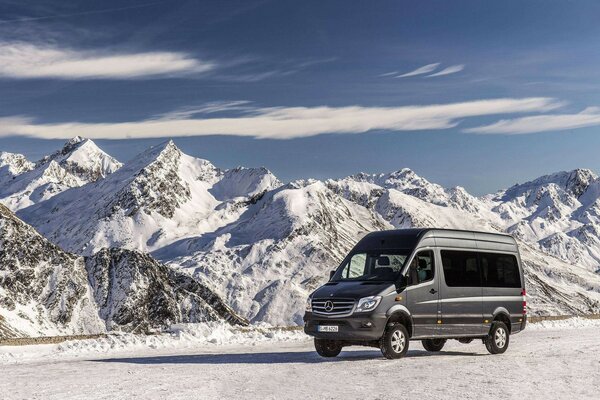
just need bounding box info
[441,250,481,287]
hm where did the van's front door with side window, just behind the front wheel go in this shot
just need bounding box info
[406,250,440,337]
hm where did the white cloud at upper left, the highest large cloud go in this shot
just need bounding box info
[0,42,216,79]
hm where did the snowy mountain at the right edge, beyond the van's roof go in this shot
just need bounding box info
[484,169,600,271]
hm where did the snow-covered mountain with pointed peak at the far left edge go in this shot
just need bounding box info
[0,136,121,211]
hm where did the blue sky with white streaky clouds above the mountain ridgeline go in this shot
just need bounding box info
[0,0,600,194]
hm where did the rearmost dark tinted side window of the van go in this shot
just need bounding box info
[480,253,521,288]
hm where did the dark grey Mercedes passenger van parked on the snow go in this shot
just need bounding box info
[304,229,527,359]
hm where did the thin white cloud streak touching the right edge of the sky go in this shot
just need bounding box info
[464,107,600,135]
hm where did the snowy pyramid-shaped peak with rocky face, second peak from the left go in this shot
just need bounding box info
[19,141,281,255]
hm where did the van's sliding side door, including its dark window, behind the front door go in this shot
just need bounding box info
[439,250,485,337]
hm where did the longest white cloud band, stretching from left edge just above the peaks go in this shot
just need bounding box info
[0,97,562,139]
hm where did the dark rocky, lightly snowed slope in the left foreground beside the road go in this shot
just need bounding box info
[0,205,248,338]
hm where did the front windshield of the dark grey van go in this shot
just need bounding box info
[331,250,410,282]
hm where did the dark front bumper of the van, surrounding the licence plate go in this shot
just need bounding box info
[304,312,387,341]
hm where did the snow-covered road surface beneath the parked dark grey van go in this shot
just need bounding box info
[0,326,600,400]
